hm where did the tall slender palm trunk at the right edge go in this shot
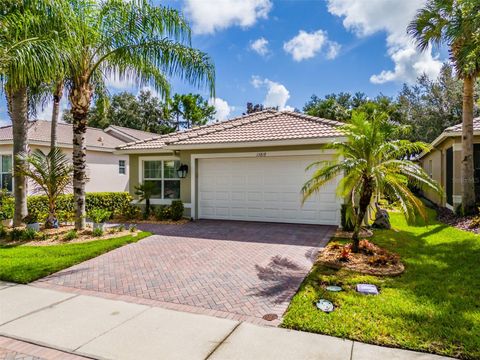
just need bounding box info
[462,76,475,214]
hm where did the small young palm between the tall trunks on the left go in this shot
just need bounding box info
[19,147,73,229]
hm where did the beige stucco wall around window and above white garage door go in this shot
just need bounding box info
[129,144,334,216]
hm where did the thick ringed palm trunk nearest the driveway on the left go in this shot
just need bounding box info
[70,82,92,230]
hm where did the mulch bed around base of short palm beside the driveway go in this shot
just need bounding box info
[318,240,405,276]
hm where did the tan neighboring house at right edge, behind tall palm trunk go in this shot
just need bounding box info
[420,118,480,210]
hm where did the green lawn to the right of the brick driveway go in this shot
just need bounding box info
[282,212,480,359]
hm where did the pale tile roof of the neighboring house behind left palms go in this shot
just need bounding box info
[0,120,125,150]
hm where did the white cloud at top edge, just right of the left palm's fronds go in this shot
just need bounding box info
[185,0,272,34]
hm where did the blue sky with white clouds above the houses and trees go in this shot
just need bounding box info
[0,0,445,123]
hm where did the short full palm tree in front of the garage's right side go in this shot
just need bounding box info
[302,111,441,252]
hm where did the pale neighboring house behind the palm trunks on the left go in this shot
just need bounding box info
[0,120,158,194]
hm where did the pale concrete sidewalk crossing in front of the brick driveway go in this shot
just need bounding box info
[0,283,447,360]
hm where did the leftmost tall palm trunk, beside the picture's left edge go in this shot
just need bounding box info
[7,87,28,226]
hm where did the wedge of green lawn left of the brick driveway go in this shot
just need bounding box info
[0,232,151,284]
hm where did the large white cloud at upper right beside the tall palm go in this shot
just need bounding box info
[328,0,442,84]
